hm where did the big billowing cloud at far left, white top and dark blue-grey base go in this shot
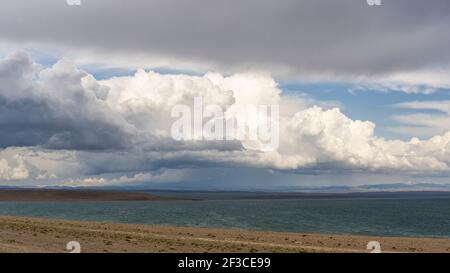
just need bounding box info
[0,52,133,150]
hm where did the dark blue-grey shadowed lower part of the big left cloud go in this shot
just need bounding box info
[0,96,131,150]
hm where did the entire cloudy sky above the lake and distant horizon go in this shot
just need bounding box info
[0,0,450,190]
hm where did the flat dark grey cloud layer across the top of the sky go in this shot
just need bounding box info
[0,0,450,75]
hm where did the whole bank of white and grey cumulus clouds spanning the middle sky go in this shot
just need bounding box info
[0,52,450,184]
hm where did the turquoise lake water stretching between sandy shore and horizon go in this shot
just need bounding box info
[0,198,450,238]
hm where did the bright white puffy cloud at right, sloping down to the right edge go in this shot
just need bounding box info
[280,107,450,172]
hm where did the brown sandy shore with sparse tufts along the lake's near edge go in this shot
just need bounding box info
[0,217,450,253]
